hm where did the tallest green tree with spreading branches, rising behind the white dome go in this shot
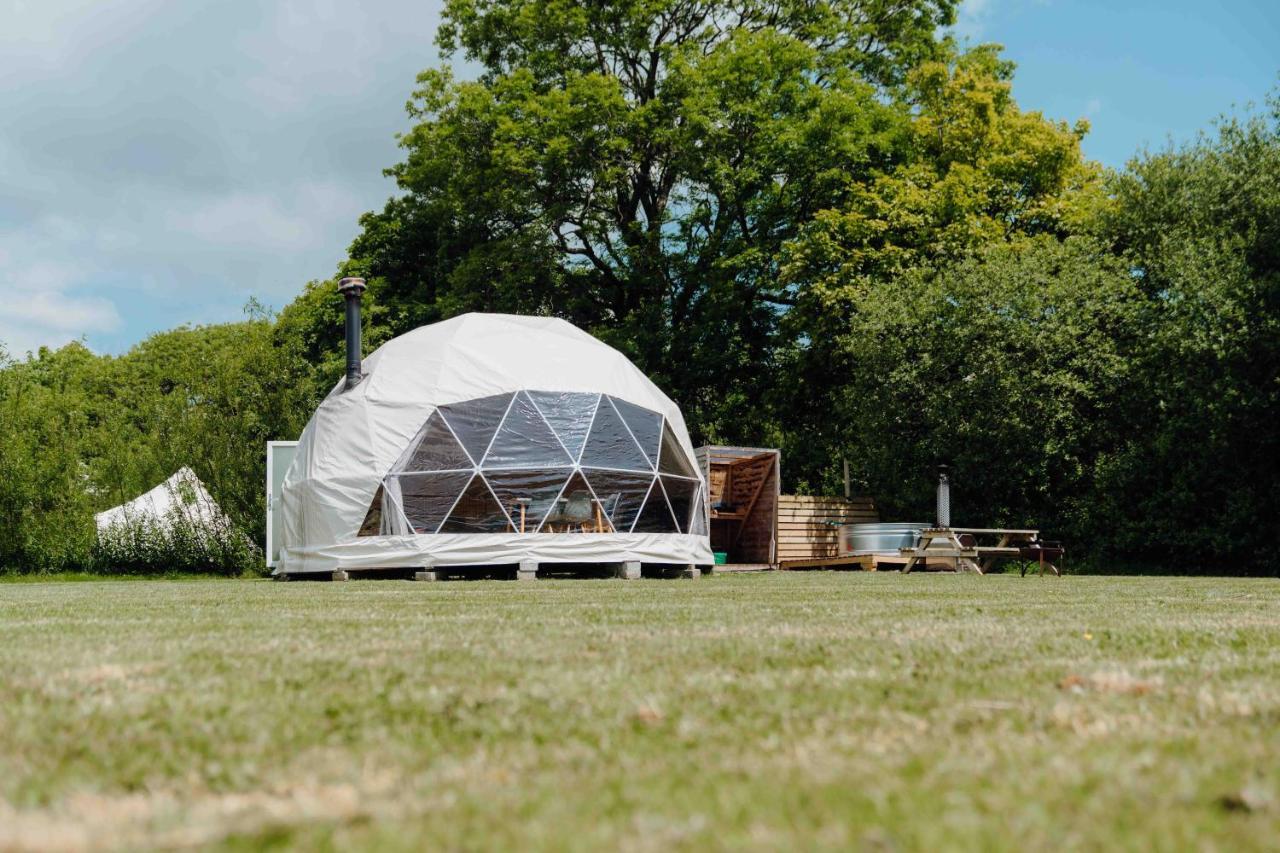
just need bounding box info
[347,0,955,437]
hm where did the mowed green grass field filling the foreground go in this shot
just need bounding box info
[0,573,1280,850]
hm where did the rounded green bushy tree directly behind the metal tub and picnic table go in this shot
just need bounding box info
[785,237,1142,532]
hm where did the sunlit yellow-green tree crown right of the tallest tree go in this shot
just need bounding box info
[781,46,1105,384]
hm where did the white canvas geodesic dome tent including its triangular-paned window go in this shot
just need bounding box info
[275,314,712,574]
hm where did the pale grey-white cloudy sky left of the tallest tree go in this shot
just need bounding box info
[0,0,442,351]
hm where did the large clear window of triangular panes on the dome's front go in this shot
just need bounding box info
[371,391,705,537]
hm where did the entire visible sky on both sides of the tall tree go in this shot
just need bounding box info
[0,0,1280,353]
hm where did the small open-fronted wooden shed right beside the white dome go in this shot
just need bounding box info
[694,446,782,566]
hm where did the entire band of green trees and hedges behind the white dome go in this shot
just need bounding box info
[0,0,1280,571]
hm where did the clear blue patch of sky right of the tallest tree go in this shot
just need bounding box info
[956,0,1280,168]
